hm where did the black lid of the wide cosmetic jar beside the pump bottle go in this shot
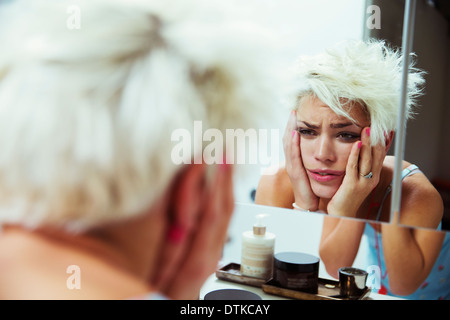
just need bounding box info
[273,252,320,272]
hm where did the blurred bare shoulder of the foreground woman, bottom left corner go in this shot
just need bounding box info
[0,228,149,300]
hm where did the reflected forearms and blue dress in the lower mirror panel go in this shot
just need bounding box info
[319,216,450,300]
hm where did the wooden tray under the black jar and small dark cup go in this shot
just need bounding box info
[261,278,371,300]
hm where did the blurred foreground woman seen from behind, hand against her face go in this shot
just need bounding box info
[0,0,278,299]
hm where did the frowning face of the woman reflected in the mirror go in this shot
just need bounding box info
[297,96,370,199]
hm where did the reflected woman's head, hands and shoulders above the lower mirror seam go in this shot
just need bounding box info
[255,40,443,229]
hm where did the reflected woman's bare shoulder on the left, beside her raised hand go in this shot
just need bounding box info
[255,163,294,209]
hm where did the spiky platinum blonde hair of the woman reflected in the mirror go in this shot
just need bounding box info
[295,39,425,145]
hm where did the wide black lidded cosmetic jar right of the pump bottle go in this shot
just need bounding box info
[273,252,320,294]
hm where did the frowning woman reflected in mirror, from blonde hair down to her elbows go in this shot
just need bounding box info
[255,40,444,295]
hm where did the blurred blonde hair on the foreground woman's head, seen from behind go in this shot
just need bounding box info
[0,0,276,230]
